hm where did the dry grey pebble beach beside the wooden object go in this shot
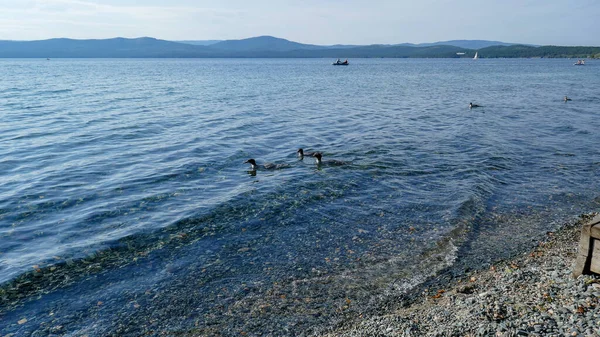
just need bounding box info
[324,214,600,337]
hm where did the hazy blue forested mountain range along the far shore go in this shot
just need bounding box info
[0,36,600,58]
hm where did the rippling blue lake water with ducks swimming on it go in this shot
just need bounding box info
[0,59,600,336]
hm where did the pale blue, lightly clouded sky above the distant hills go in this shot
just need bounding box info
[0,0,600,46]
